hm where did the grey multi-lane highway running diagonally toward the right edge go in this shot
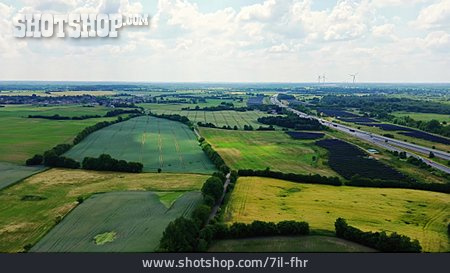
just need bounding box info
[270,94,450,173]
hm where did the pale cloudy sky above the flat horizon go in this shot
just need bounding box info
[0,0,450,84]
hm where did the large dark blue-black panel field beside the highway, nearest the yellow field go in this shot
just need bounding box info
[316,139,405,180]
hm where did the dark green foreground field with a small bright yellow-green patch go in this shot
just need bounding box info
[31,192,202,252]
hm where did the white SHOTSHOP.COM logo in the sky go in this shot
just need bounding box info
[13,13,149,38]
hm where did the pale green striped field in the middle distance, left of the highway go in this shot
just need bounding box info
[150,110,270,130]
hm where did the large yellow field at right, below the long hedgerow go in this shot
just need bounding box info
[224,177,450,252]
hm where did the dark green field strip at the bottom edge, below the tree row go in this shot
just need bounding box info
[208,235,374,252]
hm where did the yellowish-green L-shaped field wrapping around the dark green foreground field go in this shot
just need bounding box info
[0,169,208,252]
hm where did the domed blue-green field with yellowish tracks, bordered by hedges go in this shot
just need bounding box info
[65,116,215,173]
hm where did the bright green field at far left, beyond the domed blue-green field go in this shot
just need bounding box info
[0,106,115,164]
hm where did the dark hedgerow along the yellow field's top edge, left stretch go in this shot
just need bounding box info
[238,168,342,186]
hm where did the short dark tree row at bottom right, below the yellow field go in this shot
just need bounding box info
[334,218,422,252]
